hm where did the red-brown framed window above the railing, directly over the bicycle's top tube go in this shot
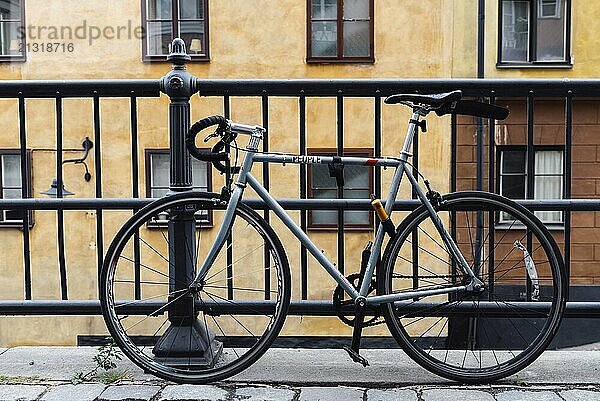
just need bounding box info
[307,0,375,62]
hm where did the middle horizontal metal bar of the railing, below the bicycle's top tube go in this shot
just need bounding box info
[0,198,600,212]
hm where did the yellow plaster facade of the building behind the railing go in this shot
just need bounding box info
[0,0,600,346]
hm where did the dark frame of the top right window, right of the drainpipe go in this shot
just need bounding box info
[496,0,573,68]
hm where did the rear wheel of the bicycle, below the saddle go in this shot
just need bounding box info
[383,192,567,383]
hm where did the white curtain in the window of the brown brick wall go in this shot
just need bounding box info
[534,150,563,223]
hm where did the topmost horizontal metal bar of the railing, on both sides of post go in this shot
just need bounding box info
[0,78,600,98]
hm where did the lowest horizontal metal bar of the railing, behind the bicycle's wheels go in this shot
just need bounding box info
[0,300,600,318]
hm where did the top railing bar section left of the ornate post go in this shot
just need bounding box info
[0,79,161,98]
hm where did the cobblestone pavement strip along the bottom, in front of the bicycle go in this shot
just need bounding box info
[0,382,600,401]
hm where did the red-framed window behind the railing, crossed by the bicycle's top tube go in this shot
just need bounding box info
[307,149,373,230]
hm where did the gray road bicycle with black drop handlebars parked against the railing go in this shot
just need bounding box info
[100,91,567,383]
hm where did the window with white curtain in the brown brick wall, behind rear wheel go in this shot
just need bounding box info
[499,148,564,224]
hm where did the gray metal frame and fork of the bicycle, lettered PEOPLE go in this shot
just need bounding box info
[191,112,481,305]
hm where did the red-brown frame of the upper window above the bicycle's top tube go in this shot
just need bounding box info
[306,0,375,63]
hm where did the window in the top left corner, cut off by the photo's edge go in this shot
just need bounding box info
[0,0,25,61]
